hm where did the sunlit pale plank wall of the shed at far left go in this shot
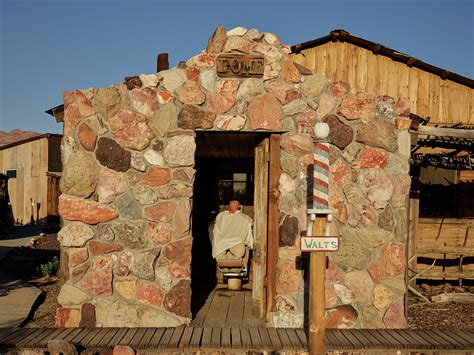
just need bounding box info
[0,137,48,224]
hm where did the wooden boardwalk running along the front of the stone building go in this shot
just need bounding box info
[0,326,474,354]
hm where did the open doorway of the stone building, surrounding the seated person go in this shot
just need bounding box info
[191,131,279,326]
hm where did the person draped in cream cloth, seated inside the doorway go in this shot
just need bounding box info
[210,200,253,259]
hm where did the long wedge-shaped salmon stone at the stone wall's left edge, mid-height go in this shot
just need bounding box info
[58,195,118,224]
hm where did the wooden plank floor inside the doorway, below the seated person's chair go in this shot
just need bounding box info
[191,285,265,327]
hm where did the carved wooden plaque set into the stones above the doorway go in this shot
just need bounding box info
[216,54,265,78]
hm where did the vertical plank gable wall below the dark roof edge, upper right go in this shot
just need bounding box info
[290,42,474,125]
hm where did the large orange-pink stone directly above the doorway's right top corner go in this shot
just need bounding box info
[247,94,285,130]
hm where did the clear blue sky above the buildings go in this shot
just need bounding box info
[0,0,474,133]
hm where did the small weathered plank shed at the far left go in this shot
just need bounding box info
[0,134,62,225]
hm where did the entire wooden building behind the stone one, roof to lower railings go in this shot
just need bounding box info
[290,30,474,284]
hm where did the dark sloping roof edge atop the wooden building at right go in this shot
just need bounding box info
[291,29,474,89]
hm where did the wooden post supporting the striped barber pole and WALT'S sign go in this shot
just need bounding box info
[309,215,327,354]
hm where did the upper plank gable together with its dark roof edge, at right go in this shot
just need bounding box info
[290,30,474,125]
